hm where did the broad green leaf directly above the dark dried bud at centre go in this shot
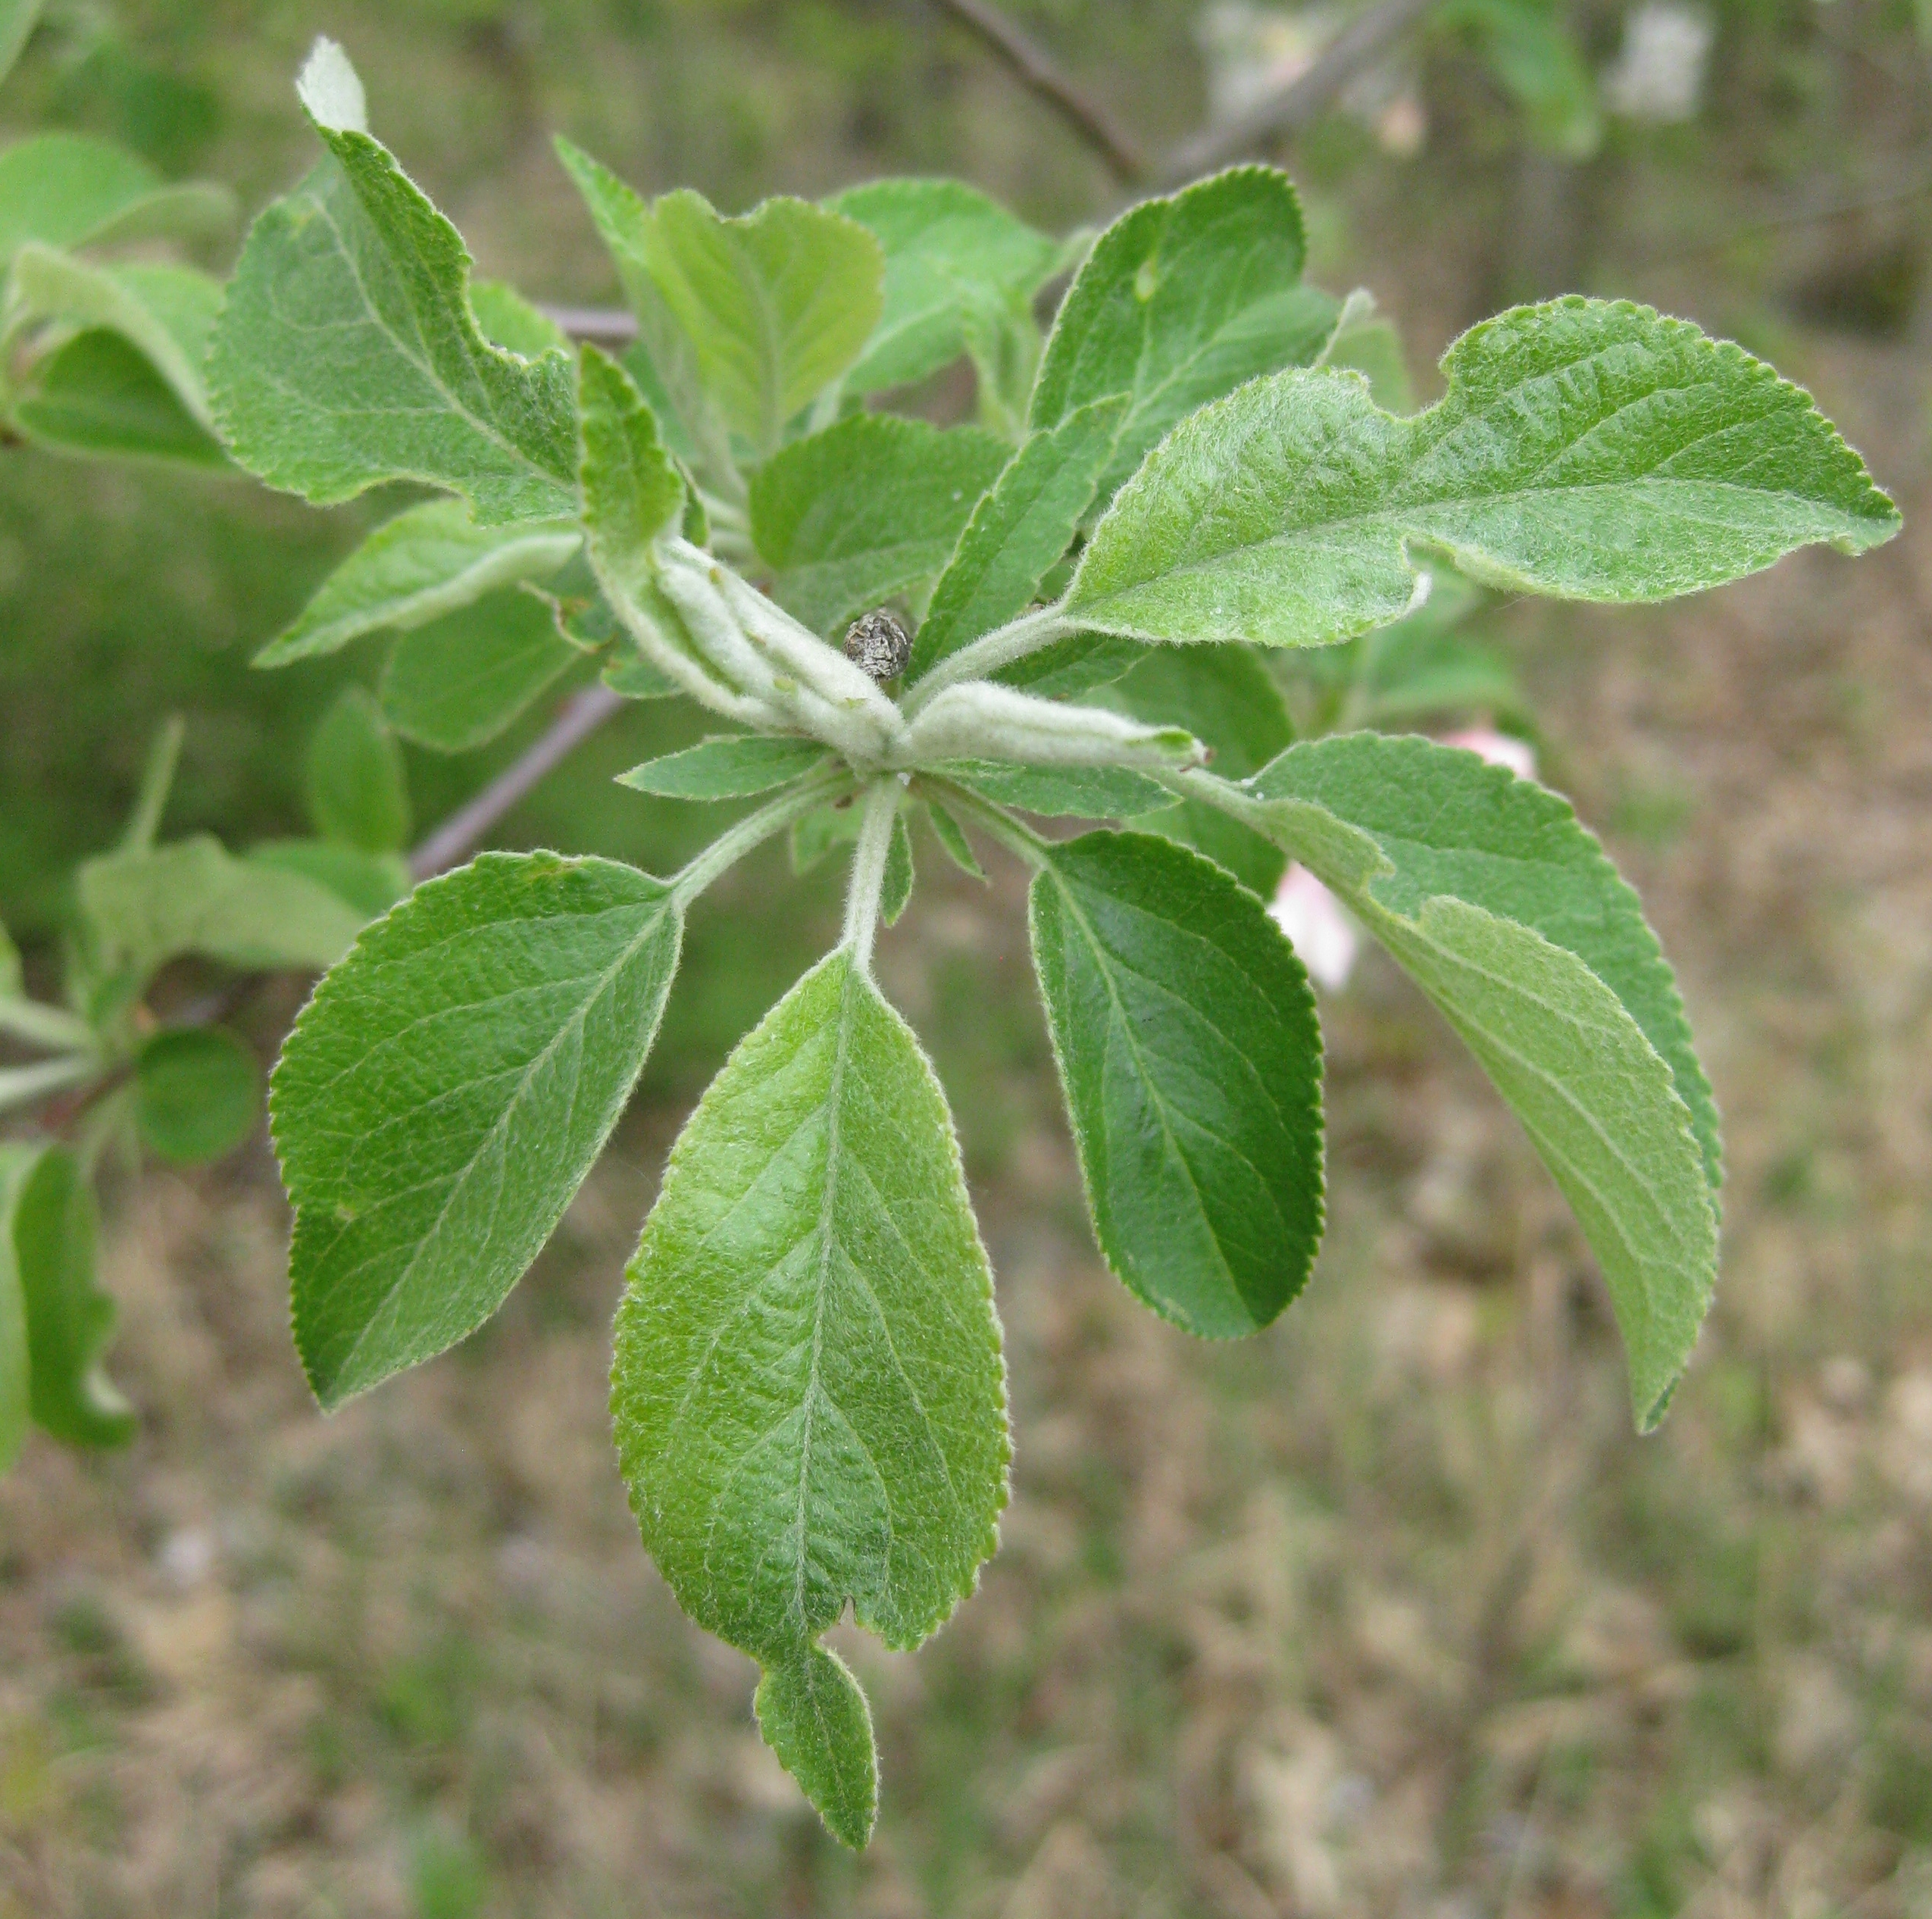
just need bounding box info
[752,414,1008,636]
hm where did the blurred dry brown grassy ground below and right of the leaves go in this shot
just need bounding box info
[0,348,1932,1919]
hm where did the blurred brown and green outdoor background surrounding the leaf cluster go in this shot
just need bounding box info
[0,0,1932,1919]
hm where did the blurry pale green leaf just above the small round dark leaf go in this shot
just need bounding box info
[77,835,363,980]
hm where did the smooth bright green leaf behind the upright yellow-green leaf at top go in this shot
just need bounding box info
[827,180,1058,394]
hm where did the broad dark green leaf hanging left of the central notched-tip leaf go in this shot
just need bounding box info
[268,852,684,1407]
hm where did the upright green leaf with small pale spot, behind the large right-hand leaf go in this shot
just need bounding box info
[1032,166,1341,505]
